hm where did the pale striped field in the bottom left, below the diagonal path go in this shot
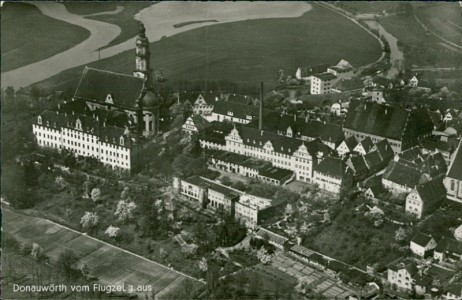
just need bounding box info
[3,208,202,298]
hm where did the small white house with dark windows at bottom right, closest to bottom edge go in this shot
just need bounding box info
[387,260,418,291]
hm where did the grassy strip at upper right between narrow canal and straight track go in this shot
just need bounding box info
[379,15,462,67]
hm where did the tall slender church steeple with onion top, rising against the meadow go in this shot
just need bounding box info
[133,22,152,87]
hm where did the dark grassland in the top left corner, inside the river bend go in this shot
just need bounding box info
[1,2,90,72]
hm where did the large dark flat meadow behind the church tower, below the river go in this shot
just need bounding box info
[31,4,381,89]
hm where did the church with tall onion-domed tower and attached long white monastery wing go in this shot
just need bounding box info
[32,24,160,172]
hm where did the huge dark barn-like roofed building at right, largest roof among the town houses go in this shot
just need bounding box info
[343,100,433,153]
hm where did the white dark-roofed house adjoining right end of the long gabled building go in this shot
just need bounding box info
[313,156,353,194]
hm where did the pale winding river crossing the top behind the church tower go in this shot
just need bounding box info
[2,1,311,89]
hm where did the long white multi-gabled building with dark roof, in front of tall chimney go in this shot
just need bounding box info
[199,126,332,182]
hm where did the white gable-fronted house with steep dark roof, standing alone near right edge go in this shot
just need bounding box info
[405,178,446,219]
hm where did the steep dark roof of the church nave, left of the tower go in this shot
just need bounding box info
[74,67,144,109]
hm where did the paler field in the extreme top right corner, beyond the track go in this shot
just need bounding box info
[415,2,462,46]
